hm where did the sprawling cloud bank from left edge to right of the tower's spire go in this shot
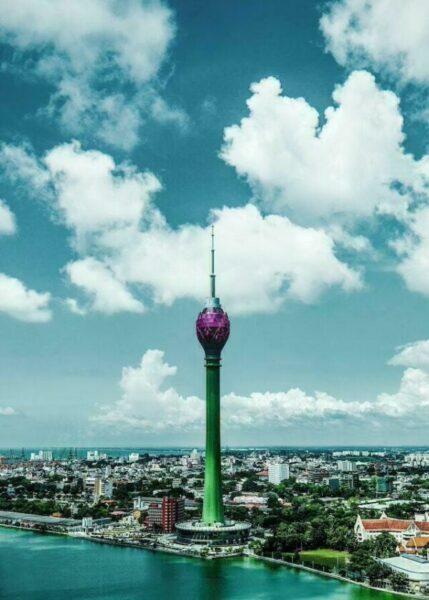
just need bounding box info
[0,142,358,314]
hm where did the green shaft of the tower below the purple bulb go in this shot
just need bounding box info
[203,356,224,524]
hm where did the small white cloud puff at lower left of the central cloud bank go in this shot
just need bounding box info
[65,257,144,315]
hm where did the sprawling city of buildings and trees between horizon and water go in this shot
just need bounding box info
[0,448,429,592]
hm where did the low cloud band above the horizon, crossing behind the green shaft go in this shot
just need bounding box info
[91,350,429,433]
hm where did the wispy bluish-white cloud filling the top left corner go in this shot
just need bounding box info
[0,0,180,149]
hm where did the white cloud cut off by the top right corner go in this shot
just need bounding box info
[320,0,429,85]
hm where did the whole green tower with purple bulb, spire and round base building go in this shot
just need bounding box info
[176,227,250,545]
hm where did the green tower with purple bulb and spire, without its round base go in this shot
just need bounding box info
[196,226,230,525]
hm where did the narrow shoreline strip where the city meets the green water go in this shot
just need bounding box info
[0,523,429,600]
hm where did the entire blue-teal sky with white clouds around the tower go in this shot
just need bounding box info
[0,0,429,447]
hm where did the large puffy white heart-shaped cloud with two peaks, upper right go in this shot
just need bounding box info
[221,71,424,223]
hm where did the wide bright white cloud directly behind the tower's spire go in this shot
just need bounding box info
[109,204,362,314]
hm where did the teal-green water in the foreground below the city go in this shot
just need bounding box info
[0,529,397,600]
